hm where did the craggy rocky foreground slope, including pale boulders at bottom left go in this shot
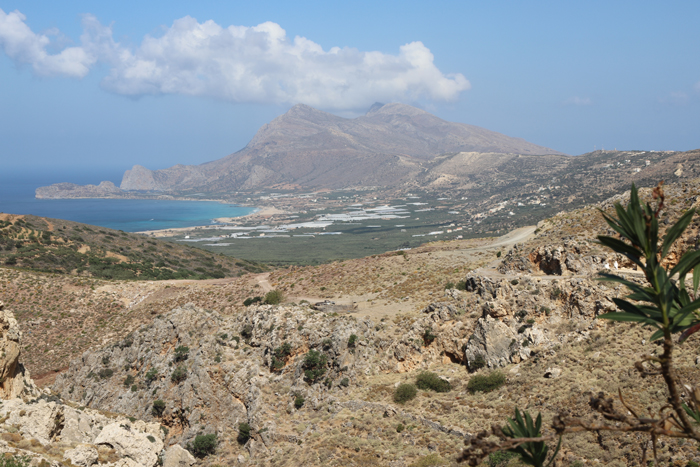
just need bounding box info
[0,181,700,467]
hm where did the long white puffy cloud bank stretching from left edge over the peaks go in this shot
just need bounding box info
[0,10,470,109]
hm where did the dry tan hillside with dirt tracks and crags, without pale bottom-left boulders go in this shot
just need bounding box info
[0,180,700,467]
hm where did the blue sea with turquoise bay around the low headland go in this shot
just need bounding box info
[0,169,255,232]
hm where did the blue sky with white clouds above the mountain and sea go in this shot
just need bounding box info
[0,0,700,182]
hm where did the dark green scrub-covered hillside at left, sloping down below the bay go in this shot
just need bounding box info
[0,214,263,280]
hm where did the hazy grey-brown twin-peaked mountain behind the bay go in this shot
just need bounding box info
[115,103,561,193]
